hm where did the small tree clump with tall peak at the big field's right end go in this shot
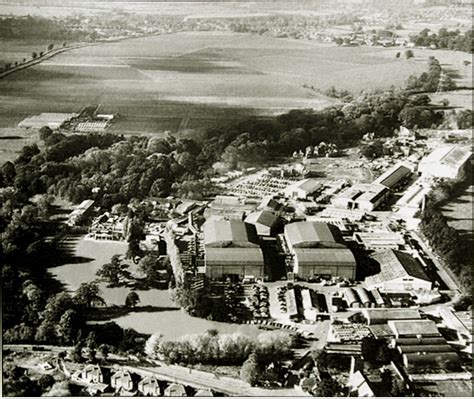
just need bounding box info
[406,57,456,92]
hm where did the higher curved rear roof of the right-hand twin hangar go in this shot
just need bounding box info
[285,222,342,248]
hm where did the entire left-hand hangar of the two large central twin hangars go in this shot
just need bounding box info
[204,220,264,280]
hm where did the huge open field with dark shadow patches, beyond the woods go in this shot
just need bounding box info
[0,32,436,139]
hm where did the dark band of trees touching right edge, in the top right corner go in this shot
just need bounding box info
[410,28,474,53]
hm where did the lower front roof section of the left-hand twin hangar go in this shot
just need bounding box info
[205,247,263,266]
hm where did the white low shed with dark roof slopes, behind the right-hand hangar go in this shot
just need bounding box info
[331,183,388,212]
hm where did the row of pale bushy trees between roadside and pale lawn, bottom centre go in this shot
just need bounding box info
[145,330,295,365]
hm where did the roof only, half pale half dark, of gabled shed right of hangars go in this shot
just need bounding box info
[365,249,431,285]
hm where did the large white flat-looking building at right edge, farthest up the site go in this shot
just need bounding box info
[418,146,472,179]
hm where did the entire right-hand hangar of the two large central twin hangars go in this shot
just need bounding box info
[284,222,356,279]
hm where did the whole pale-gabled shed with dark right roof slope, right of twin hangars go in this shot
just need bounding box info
[365,249,432,292]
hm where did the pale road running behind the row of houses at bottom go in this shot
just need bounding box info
[124,363,304,397]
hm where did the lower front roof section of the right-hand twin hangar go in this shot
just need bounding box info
[294,248,356,267]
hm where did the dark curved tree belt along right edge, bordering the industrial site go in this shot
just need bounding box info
[420,173,473,292]
